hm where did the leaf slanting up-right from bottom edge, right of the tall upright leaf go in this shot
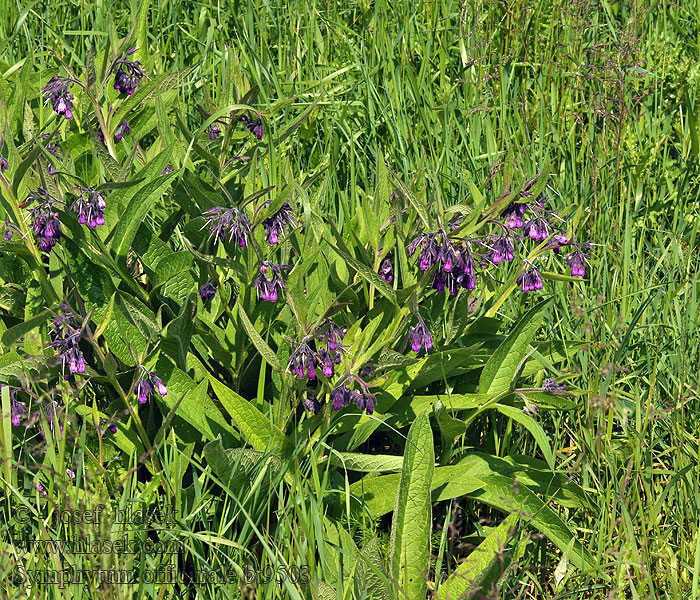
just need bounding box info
[437,513,518,600]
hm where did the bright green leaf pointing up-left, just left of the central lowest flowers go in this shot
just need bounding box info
[209,375,285,452]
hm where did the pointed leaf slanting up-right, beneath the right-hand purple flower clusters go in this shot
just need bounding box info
[479,298,551,394]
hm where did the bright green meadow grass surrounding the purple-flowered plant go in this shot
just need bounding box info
[0,0,700,598]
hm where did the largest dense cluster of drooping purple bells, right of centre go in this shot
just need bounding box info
[408,231,476,295]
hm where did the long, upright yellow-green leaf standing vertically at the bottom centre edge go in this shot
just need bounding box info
[389,411,435,598]
